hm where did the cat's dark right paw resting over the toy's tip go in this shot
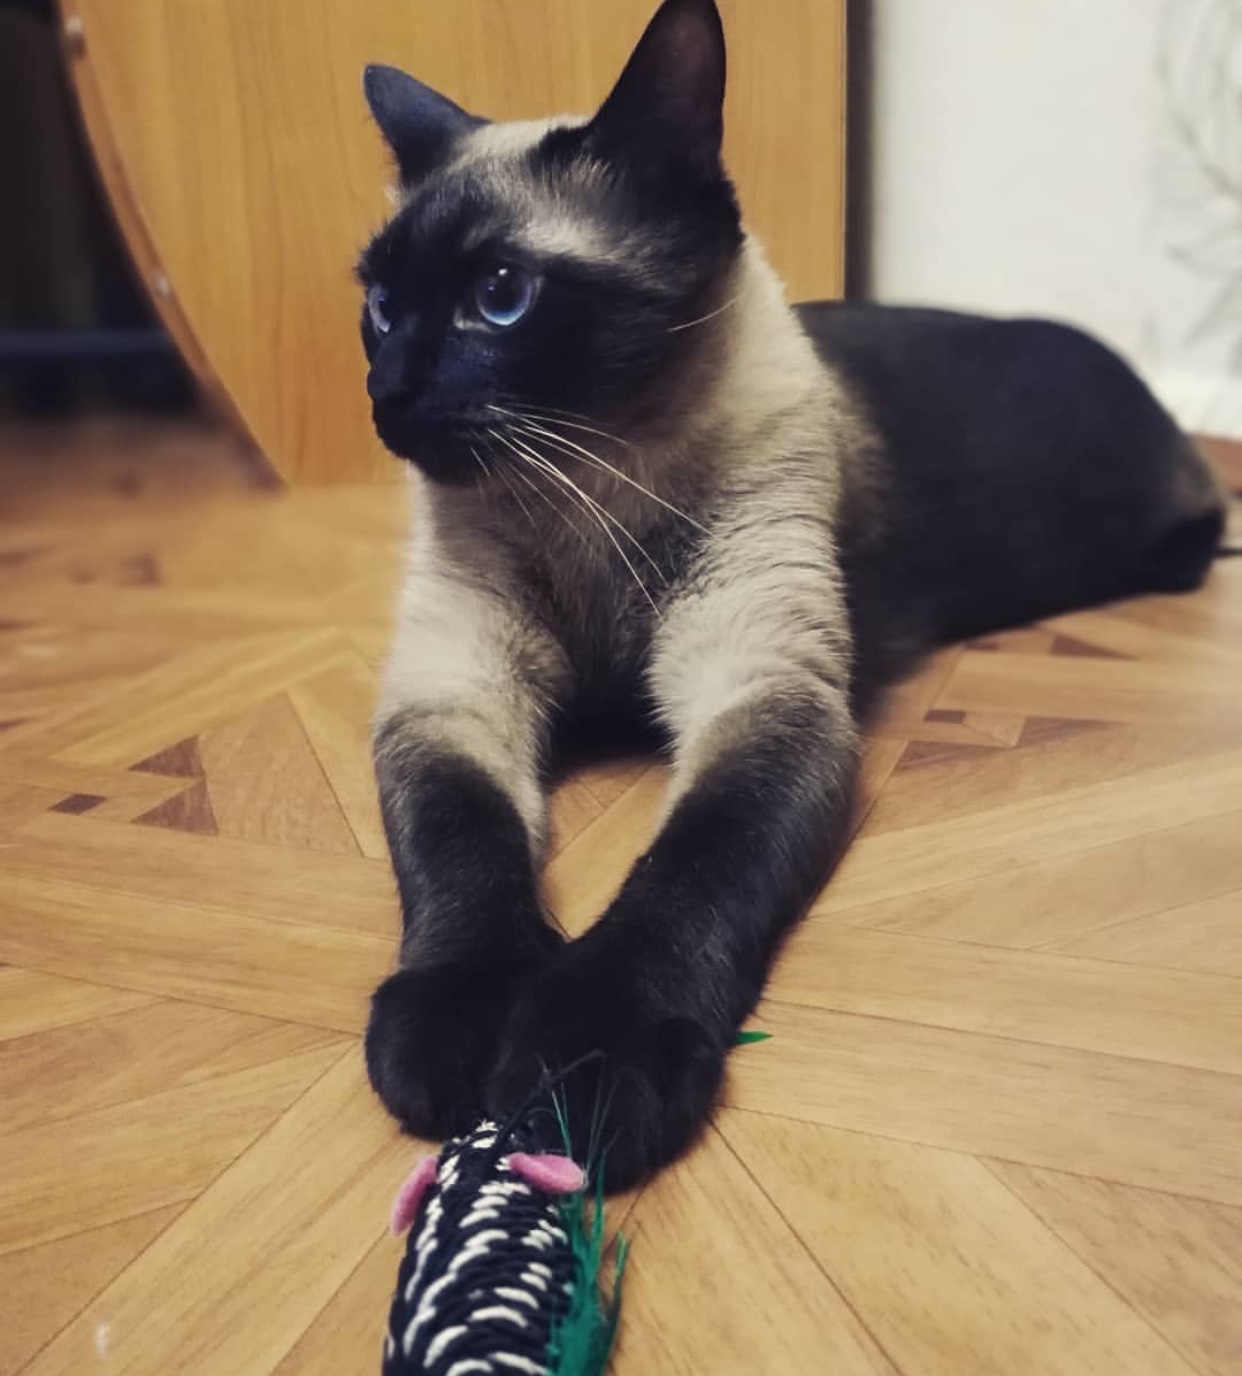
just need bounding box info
[487,947,726,1193]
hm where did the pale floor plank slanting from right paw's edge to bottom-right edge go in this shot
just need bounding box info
[722,1112,1194,1376]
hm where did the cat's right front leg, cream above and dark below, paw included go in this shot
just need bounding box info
[490,550,858,1190]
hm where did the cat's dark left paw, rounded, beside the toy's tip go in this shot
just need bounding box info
[366,963,558,1138]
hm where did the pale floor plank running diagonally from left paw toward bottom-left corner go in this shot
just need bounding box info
[29,1051,411,1376]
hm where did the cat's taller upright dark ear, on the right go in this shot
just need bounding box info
[587,0,725,175]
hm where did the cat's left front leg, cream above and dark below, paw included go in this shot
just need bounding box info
[366,572,561,1137]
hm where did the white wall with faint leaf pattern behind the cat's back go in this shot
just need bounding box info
[869,0,1242,436]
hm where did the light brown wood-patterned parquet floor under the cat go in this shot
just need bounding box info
[0,422,1242,1376]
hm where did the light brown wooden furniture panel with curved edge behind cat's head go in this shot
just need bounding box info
[62,0,845,482]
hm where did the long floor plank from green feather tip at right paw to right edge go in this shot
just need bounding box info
[725,1003,1242,1204]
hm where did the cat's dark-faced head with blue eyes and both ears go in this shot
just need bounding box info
[359,0,743,483]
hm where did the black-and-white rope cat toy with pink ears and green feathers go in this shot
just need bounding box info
[382,1120,626,1376]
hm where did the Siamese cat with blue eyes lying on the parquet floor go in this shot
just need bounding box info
[359,0,1224,1189]
